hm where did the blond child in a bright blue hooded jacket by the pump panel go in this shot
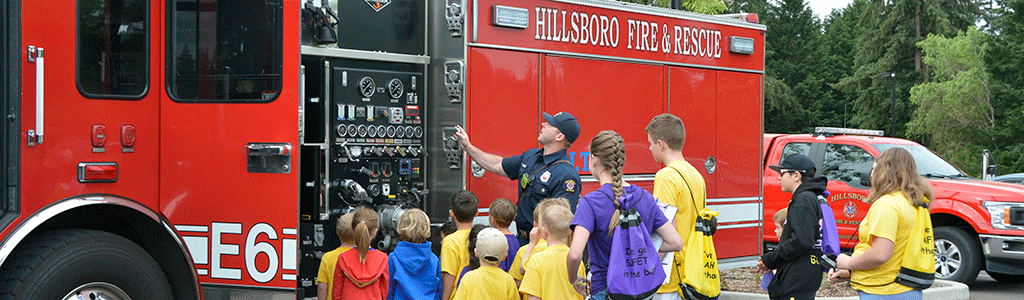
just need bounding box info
[387,209,441,300]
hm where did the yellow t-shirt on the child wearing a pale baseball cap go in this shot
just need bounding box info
[452,265,519,300]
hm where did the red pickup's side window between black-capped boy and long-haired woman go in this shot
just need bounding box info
[821,143,874,188]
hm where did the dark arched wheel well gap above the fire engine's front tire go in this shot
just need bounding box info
[7,200,200,300]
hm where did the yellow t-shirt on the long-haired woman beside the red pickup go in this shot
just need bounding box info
[850,191,916,295]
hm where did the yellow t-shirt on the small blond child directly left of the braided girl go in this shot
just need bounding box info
[519,245,583,300]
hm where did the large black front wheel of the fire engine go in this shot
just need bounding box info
[0,229,173,300]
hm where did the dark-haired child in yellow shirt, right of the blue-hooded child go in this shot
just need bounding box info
[441,190,475,300]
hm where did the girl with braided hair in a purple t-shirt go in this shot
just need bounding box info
[566,130,683,300]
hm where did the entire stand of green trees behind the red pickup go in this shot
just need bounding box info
[727,0,1024,175]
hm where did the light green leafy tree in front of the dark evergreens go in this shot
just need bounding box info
[907,28,995,172]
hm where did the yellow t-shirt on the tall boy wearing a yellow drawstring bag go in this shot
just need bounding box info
[653,161,708,293]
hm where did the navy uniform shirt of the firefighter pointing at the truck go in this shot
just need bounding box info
[502,148,581,241]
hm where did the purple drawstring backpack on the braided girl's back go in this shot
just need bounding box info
[605,194,666,300]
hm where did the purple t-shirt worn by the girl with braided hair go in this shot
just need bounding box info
[570,183,669,293]
